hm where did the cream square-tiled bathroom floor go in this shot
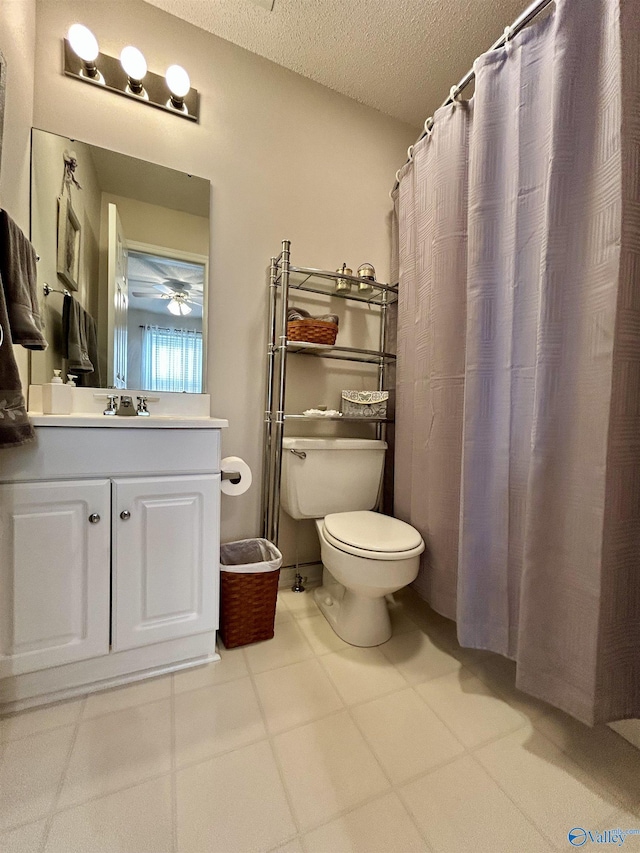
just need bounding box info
[0,591,640,853]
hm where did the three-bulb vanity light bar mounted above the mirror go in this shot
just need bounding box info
[63,24,199,121]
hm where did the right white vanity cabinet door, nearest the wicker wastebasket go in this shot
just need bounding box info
[112,474,220,651]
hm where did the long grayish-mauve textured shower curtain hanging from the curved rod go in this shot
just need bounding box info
[395,0,640,724]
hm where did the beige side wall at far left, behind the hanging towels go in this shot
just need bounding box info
[0,0,36,387]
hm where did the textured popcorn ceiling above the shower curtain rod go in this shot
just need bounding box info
[147,0,527,126]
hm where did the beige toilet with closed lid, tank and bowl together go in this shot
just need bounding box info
[280,437,424,646]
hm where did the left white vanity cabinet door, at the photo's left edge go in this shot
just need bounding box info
[0,480,111,678]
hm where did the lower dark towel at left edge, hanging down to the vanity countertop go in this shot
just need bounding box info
[0,278,35,447]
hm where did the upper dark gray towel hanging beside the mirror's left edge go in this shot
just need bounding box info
[0,210,47,349]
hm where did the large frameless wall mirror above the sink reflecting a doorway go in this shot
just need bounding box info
[31,129,209,393]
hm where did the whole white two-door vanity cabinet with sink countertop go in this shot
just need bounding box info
[0,417,226,713]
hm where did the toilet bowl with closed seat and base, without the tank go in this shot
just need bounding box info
[314,511,424,646]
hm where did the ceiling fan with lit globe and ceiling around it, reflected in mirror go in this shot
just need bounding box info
[127,251,204,317]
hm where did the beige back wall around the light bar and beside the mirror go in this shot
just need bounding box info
[35,0,415,552]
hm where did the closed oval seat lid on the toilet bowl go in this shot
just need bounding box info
[324,510,423,553]
